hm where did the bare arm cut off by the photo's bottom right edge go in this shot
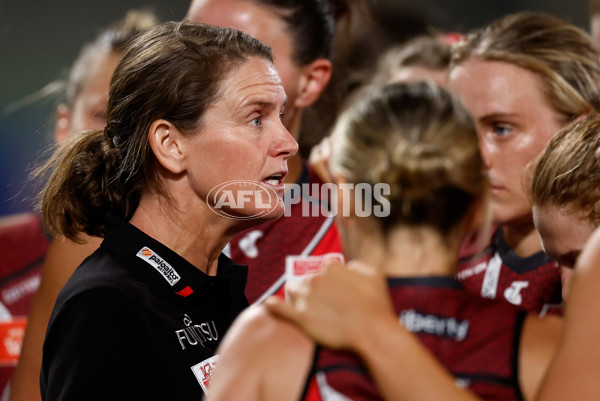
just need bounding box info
[537,229,600,401]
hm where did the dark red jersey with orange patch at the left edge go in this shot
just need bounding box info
[0,213,49,394]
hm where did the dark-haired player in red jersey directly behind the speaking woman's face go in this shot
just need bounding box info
[187,0,352,303]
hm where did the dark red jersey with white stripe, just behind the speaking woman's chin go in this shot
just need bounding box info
[229,165,342,303]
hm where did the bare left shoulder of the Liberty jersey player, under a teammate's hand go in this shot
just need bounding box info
[207,305,315,401]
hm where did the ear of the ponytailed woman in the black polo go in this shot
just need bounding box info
[148,119,185,174]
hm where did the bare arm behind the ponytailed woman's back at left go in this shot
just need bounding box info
[10,237,101,401]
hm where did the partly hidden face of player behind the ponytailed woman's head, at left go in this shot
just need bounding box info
[55,52,122,143]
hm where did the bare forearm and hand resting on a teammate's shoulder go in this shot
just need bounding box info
[266,263,478,401]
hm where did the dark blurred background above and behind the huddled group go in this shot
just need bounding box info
[0,0,589,216]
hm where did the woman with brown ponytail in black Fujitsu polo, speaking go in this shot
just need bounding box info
[38,22,297,400]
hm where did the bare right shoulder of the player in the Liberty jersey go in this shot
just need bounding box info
[518,315,563,400]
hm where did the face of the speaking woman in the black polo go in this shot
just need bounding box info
[184,57,298,218]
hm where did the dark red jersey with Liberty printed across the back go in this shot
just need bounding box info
[301,277,525,401]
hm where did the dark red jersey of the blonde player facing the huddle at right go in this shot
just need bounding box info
[457,229,562,315]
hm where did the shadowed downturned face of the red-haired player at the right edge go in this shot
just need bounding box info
[533,205,596,299]
